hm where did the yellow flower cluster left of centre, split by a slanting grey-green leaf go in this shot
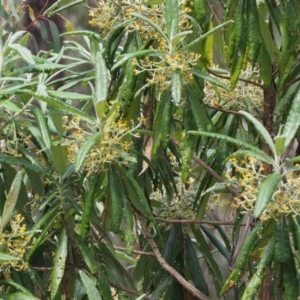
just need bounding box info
[63,117,140,175]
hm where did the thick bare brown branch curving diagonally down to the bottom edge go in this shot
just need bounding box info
[140,222,211,300]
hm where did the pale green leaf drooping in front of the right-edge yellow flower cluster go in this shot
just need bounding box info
[253,173,281,218]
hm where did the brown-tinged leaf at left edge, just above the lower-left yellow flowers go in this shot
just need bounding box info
[0,171,22,233]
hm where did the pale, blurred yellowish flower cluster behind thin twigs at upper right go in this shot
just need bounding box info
[204,64,264,111]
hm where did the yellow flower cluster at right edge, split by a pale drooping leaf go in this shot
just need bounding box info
[225,157,300,221]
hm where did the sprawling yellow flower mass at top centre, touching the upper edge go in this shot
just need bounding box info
[90,0,200,96]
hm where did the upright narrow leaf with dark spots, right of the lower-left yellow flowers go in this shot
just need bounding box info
[50,228,68,300]
